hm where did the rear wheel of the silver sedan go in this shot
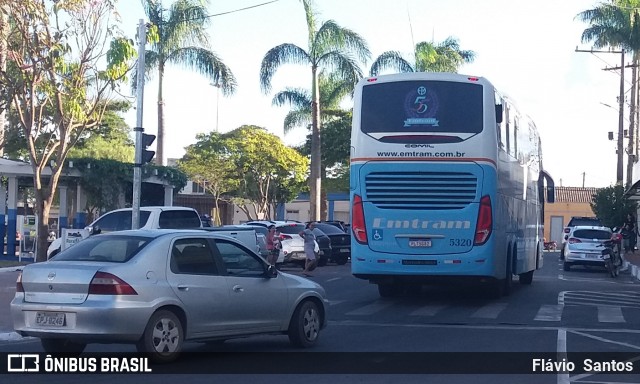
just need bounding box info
[136,310,184,363]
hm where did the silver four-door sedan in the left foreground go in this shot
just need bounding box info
[10,229,328,362]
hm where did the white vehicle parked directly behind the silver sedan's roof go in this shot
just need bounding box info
[47,206,202,258]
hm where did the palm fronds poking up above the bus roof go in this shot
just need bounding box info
[369,37,476,76]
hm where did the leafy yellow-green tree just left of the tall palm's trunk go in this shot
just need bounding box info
[223,125,309,220]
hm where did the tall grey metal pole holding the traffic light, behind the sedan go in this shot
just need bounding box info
[131,19,147,229]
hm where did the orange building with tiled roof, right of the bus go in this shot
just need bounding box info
[544,187,598,246]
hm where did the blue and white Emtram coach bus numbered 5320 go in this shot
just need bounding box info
[350,73,554,297]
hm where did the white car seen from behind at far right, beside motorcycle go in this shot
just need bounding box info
[564,225,613,271]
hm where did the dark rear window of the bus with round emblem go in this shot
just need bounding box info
[361,81,483,133]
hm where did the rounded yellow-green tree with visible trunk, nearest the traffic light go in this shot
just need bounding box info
[178,132,241,225]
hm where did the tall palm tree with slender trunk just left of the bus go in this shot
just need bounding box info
[260,0,371,220]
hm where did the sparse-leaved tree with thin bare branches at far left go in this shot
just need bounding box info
[0,0,135,261]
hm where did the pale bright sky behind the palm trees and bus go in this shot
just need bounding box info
[118,0,631,187]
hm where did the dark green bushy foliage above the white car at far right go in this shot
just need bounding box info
[590,184,637,227]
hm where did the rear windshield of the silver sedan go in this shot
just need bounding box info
[51,235,152,263]
